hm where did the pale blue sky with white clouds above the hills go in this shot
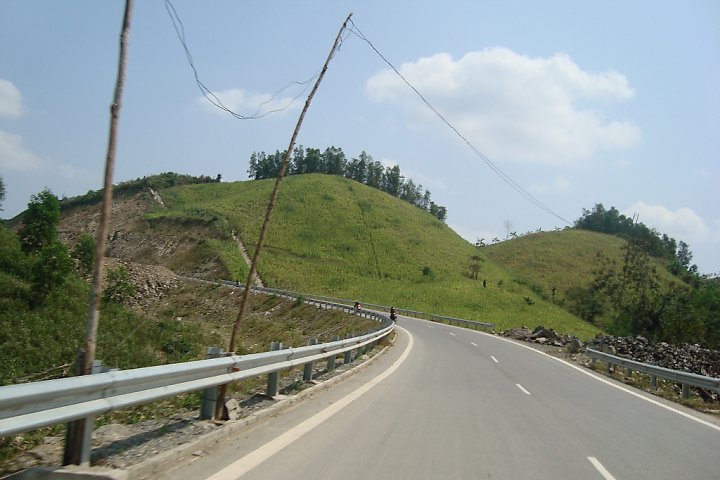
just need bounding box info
[0,0,720,273]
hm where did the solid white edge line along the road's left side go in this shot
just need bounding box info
[208,326,415,480]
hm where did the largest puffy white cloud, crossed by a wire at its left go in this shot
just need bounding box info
[366,48,641,165]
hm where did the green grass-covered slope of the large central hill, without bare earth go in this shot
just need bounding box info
[152,174,597,337]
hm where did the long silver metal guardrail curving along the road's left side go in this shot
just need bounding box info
[0,325,392,436]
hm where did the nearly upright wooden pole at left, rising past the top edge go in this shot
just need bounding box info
[63,0,133,465]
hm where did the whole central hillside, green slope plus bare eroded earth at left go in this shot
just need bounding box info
[54,174,598,338]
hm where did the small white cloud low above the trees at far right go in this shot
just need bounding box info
[623,202,711,243]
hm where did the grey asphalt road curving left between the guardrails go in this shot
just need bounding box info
[163,317,720,480]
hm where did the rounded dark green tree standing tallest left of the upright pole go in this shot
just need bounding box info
[18,189,60,253]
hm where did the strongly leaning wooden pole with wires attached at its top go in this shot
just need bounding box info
[215,13,352,418]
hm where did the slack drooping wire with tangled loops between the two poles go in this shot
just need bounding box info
[165,0,320,120]
